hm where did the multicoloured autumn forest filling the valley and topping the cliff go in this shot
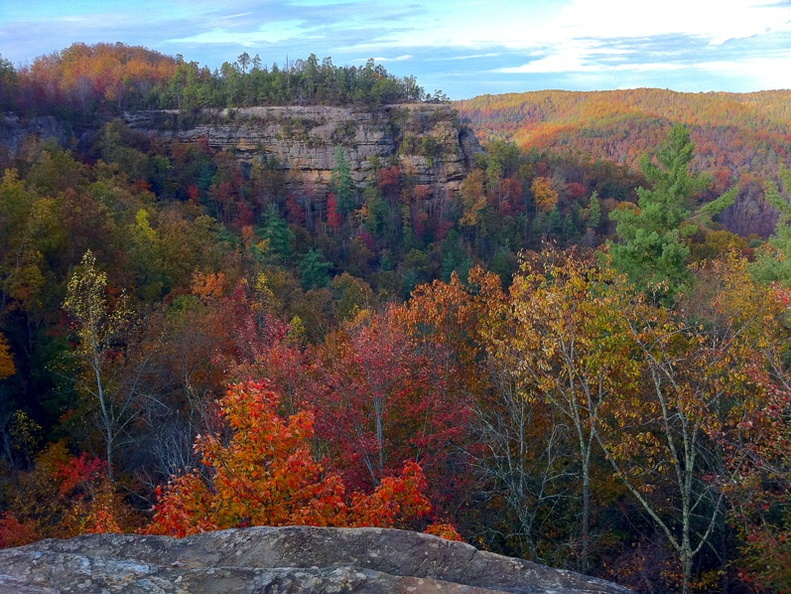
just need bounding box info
[0,44,791,594]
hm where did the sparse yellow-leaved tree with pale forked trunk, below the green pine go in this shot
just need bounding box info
[597,259,782,592]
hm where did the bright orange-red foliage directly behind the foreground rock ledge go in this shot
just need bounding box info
[148,382,458,536]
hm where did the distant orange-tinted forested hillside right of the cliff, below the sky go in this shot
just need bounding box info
[454,89,791,236]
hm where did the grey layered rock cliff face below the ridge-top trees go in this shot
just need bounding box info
[126,104,482,192]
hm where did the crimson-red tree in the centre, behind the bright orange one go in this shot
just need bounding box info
[314,307,470,496]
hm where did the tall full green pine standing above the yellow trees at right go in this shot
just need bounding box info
[609,125,736,303]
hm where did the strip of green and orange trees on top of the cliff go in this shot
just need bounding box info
[6,43,430,118]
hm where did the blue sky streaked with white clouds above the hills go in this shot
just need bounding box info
[0,0,791,99]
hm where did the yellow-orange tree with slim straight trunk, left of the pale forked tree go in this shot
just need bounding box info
[483,251,640,568]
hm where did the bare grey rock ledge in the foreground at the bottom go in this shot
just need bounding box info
[0,526,629,594]
